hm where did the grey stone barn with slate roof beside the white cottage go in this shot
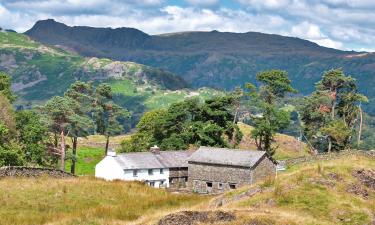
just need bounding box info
[188,147,276,193]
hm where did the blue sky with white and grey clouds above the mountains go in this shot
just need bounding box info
[0,0,375,52]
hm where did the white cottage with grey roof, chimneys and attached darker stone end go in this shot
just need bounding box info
[95,146,191,188]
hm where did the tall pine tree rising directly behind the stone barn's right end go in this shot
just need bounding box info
[246,70,296,155]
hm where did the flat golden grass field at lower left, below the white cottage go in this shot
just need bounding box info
[0,178,207,225]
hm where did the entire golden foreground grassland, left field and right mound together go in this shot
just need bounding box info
[0,156,375,225]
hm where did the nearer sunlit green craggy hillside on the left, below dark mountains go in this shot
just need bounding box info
[0,31,219,129]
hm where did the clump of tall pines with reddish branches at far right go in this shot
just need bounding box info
[300,69,368,152]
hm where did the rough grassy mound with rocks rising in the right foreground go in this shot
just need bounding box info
[216,156,375,224]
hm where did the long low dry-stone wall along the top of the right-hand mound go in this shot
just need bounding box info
[285,150,375,166]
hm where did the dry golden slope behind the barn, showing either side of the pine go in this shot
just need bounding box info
[238,123,309,159]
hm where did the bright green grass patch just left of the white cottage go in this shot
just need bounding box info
[65,147,104,175]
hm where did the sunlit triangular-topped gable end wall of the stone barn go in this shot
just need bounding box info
[252,156,276,183]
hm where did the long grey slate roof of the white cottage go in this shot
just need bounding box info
[114,151,192,169]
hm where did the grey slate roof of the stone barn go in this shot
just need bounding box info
[188,147,266,168]
